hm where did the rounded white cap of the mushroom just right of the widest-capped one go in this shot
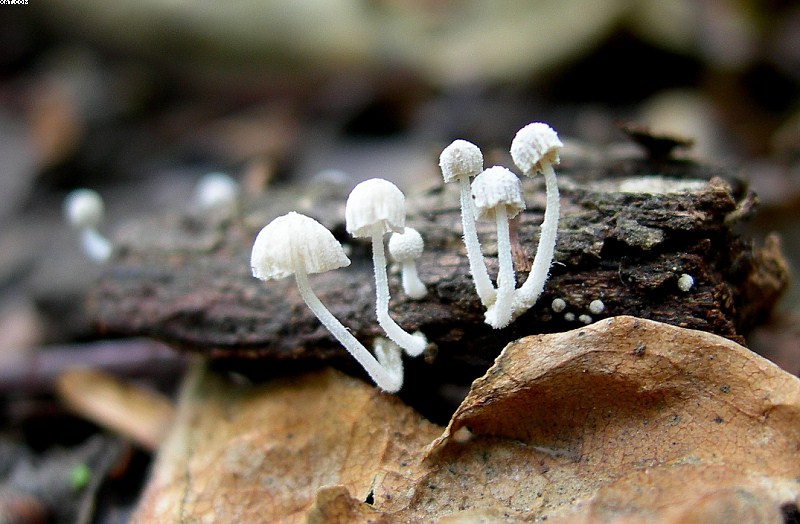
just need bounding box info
[344,178,406,237]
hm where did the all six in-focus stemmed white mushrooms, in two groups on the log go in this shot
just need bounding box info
[250,123,562,392]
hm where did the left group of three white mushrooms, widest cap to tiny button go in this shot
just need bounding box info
[250,178,427,393]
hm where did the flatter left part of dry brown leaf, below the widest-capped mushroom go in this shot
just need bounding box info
[134,362,441,523]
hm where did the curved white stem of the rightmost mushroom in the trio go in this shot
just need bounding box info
[514,161,559,314]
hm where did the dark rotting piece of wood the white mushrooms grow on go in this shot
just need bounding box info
[89,154,788,377]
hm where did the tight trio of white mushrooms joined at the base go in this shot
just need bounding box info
[439,122,562,329]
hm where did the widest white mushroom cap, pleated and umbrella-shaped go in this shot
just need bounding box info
[250,211,350,280]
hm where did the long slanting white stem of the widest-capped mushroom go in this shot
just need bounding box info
[294,269,403,393]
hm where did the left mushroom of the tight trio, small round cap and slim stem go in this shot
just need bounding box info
[439,140,497,307]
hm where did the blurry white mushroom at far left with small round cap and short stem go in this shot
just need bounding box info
[64,189,113,262]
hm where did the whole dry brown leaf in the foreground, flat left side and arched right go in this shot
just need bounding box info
[130,317,800,524]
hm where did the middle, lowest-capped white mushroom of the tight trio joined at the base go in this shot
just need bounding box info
[472,166,525,329]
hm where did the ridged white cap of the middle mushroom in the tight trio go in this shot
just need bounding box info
[472,166,525,219]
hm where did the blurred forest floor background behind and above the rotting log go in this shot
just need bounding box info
[0,0,800,520]
